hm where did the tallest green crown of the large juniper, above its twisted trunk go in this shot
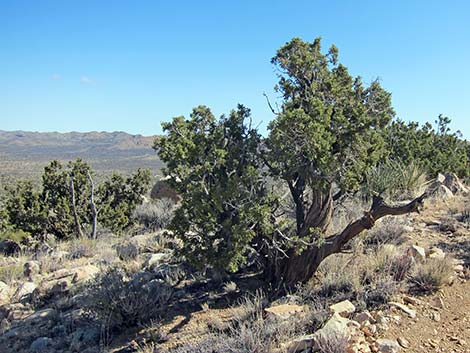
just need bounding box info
[267,38,394,192]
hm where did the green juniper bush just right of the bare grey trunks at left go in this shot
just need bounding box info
[98,169,150,233]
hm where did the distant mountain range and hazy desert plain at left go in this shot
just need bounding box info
[0,130,162,180]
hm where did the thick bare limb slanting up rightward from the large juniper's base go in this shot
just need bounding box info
[276,193,427,288]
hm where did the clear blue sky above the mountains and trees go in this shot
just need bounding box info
[0,0,470,138]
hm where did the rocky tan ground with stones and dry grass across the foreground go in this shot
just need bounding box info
[0,179,470,353]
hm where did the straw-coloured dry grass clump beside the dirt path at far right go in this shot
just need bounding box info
[410,258,453,292]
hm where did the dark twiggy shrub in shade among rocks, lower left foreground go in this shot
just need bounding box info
[87,268,173,330]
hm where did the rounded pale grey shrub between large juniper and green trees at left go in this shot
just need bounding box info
[134,198,176,231]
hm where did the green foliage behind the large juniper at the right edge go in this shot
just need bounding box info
[385,115,470,177]
